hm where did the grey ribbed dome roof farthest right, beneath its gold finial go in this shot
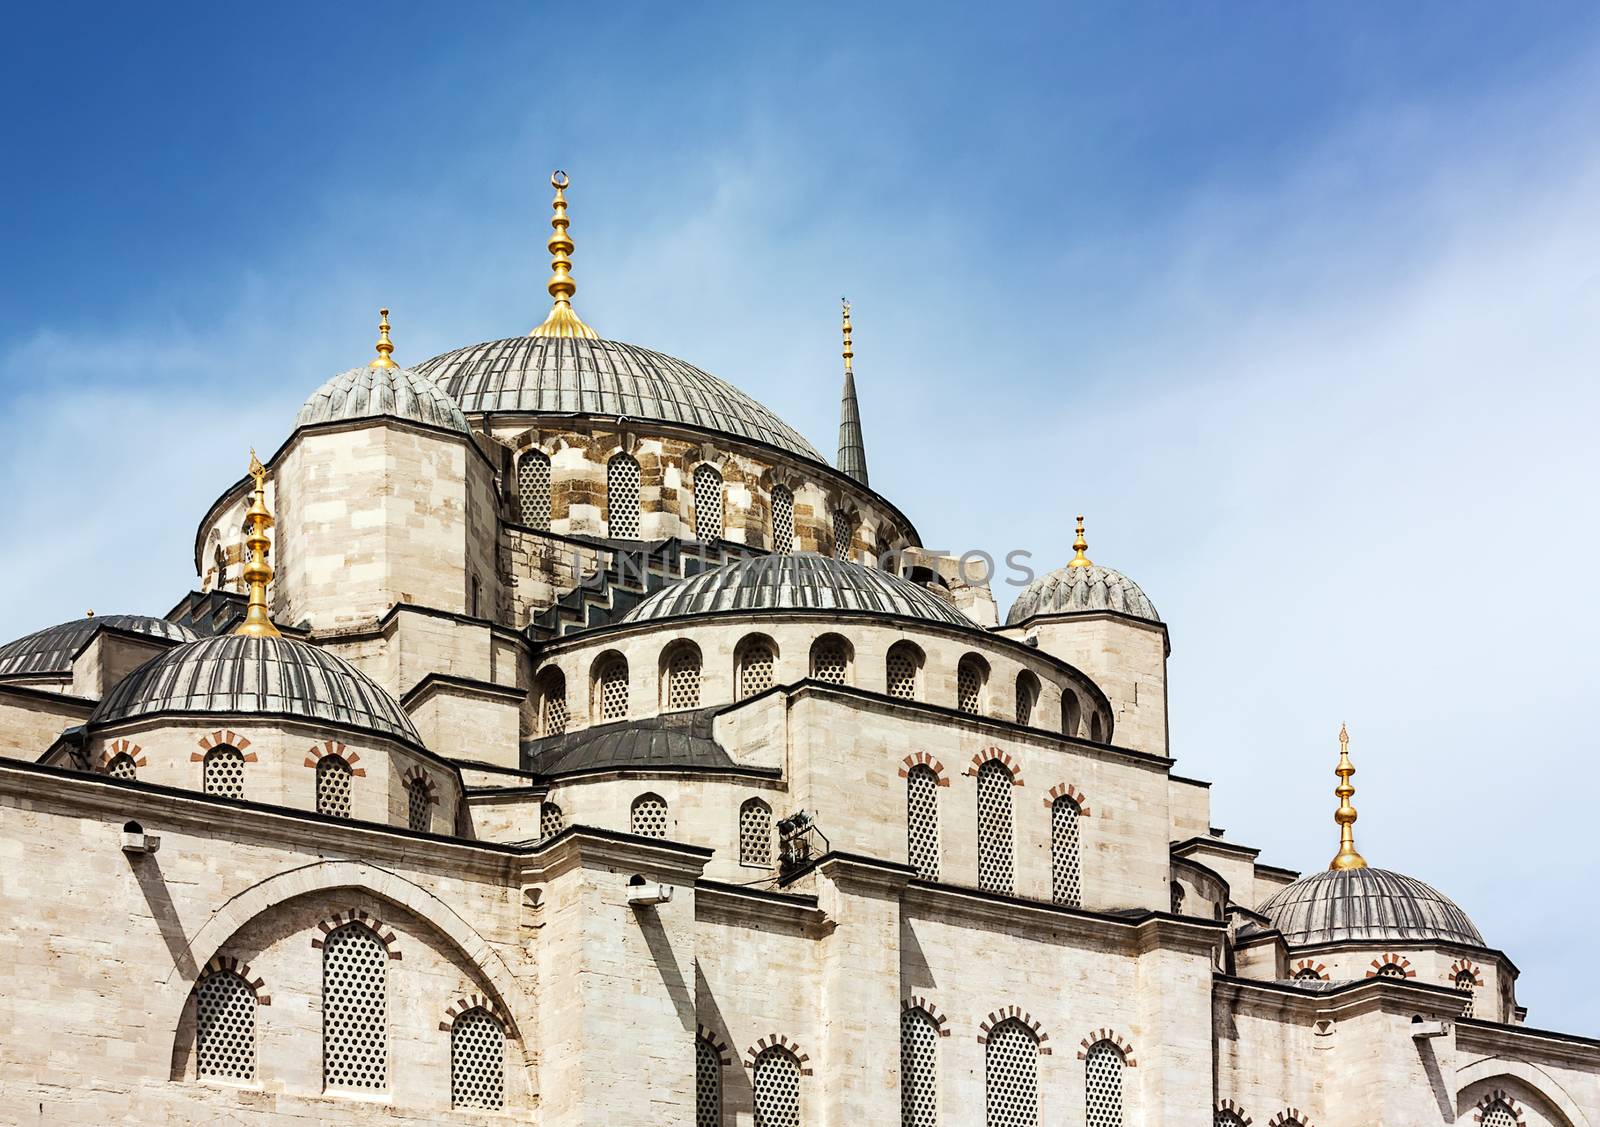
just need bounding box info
[1256,868,1483,948]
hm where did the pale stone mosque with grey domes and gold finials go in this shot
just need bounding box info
[0,173,1600,1127]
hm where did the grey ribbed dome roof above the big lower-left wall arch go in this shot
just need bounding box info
[90,634,422,744]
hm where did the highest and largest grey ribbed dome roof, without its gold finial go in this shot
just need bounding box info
[414,336,827,466]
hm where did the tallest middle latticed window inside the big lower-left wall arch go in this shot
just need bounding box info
[322,924,389,1089]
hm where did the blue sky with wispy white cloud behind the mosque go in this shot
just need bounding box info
[0,3,1600,1034]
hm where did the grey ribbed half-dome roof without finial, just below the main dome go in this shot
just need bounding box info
[621,555,978,629]
